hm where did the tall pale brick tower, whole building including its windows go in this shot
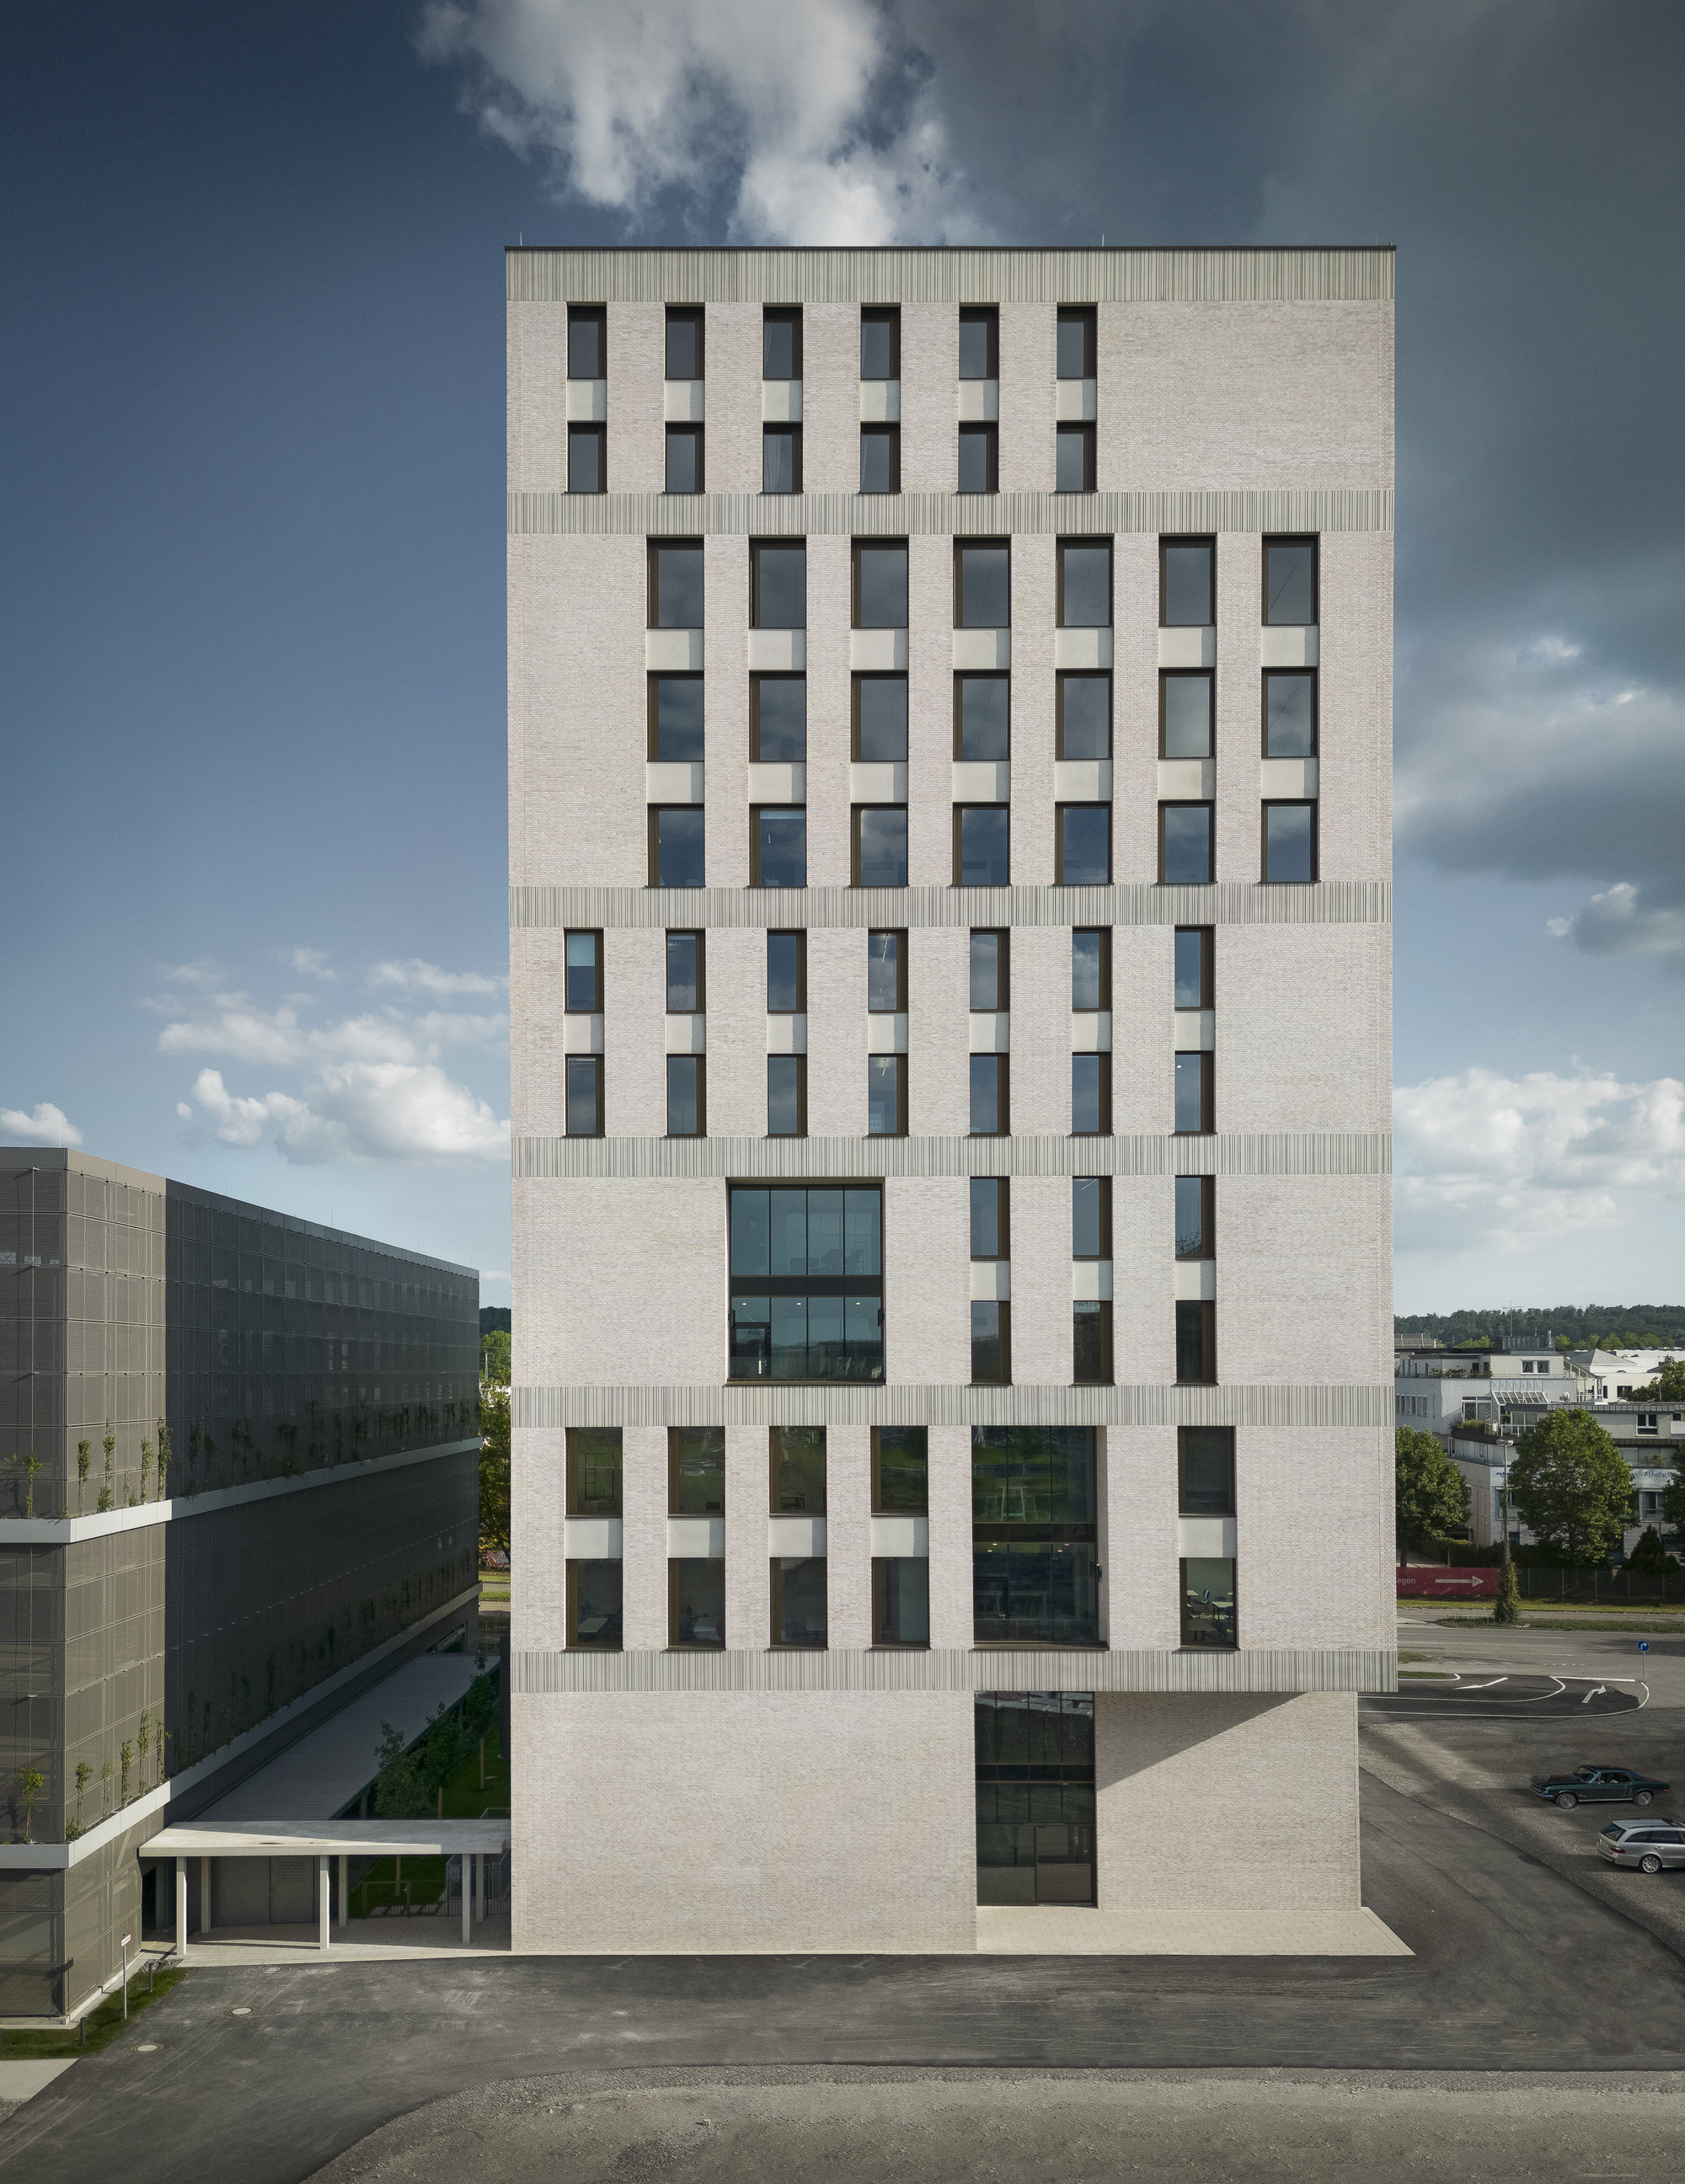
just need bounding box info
[507,249,1394,1952]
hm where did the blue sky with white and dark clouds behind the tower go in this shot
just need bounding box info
[0,0,1685,1311]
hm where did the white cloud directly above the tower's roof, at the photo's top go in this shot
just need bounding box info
[420,0,975,244]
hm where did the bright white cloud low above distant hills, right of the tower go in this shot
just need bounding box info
[1392,1068,1685,1252]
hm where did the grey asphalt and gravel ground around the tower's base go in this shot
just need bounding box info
[0,1627,1685,2184]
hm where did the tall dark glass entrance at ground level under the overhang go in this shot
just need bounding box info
[977,1690,1095,1904]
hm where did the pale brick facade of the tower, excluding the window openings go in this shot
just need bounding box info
[507,249,1397,1952]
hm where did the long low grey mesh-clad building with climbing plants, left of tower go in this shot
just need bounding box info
[0,1146,479,2016]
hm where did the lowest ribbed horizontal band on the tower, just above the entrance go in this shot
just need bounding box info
[509,1647,1399,1697]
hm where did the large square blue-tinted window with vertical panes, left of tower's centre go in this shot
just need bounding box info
[730,1183,883,1380]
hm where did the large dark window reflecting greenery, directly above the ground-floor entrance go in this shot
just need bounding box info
[971,1426,1099,1645]
